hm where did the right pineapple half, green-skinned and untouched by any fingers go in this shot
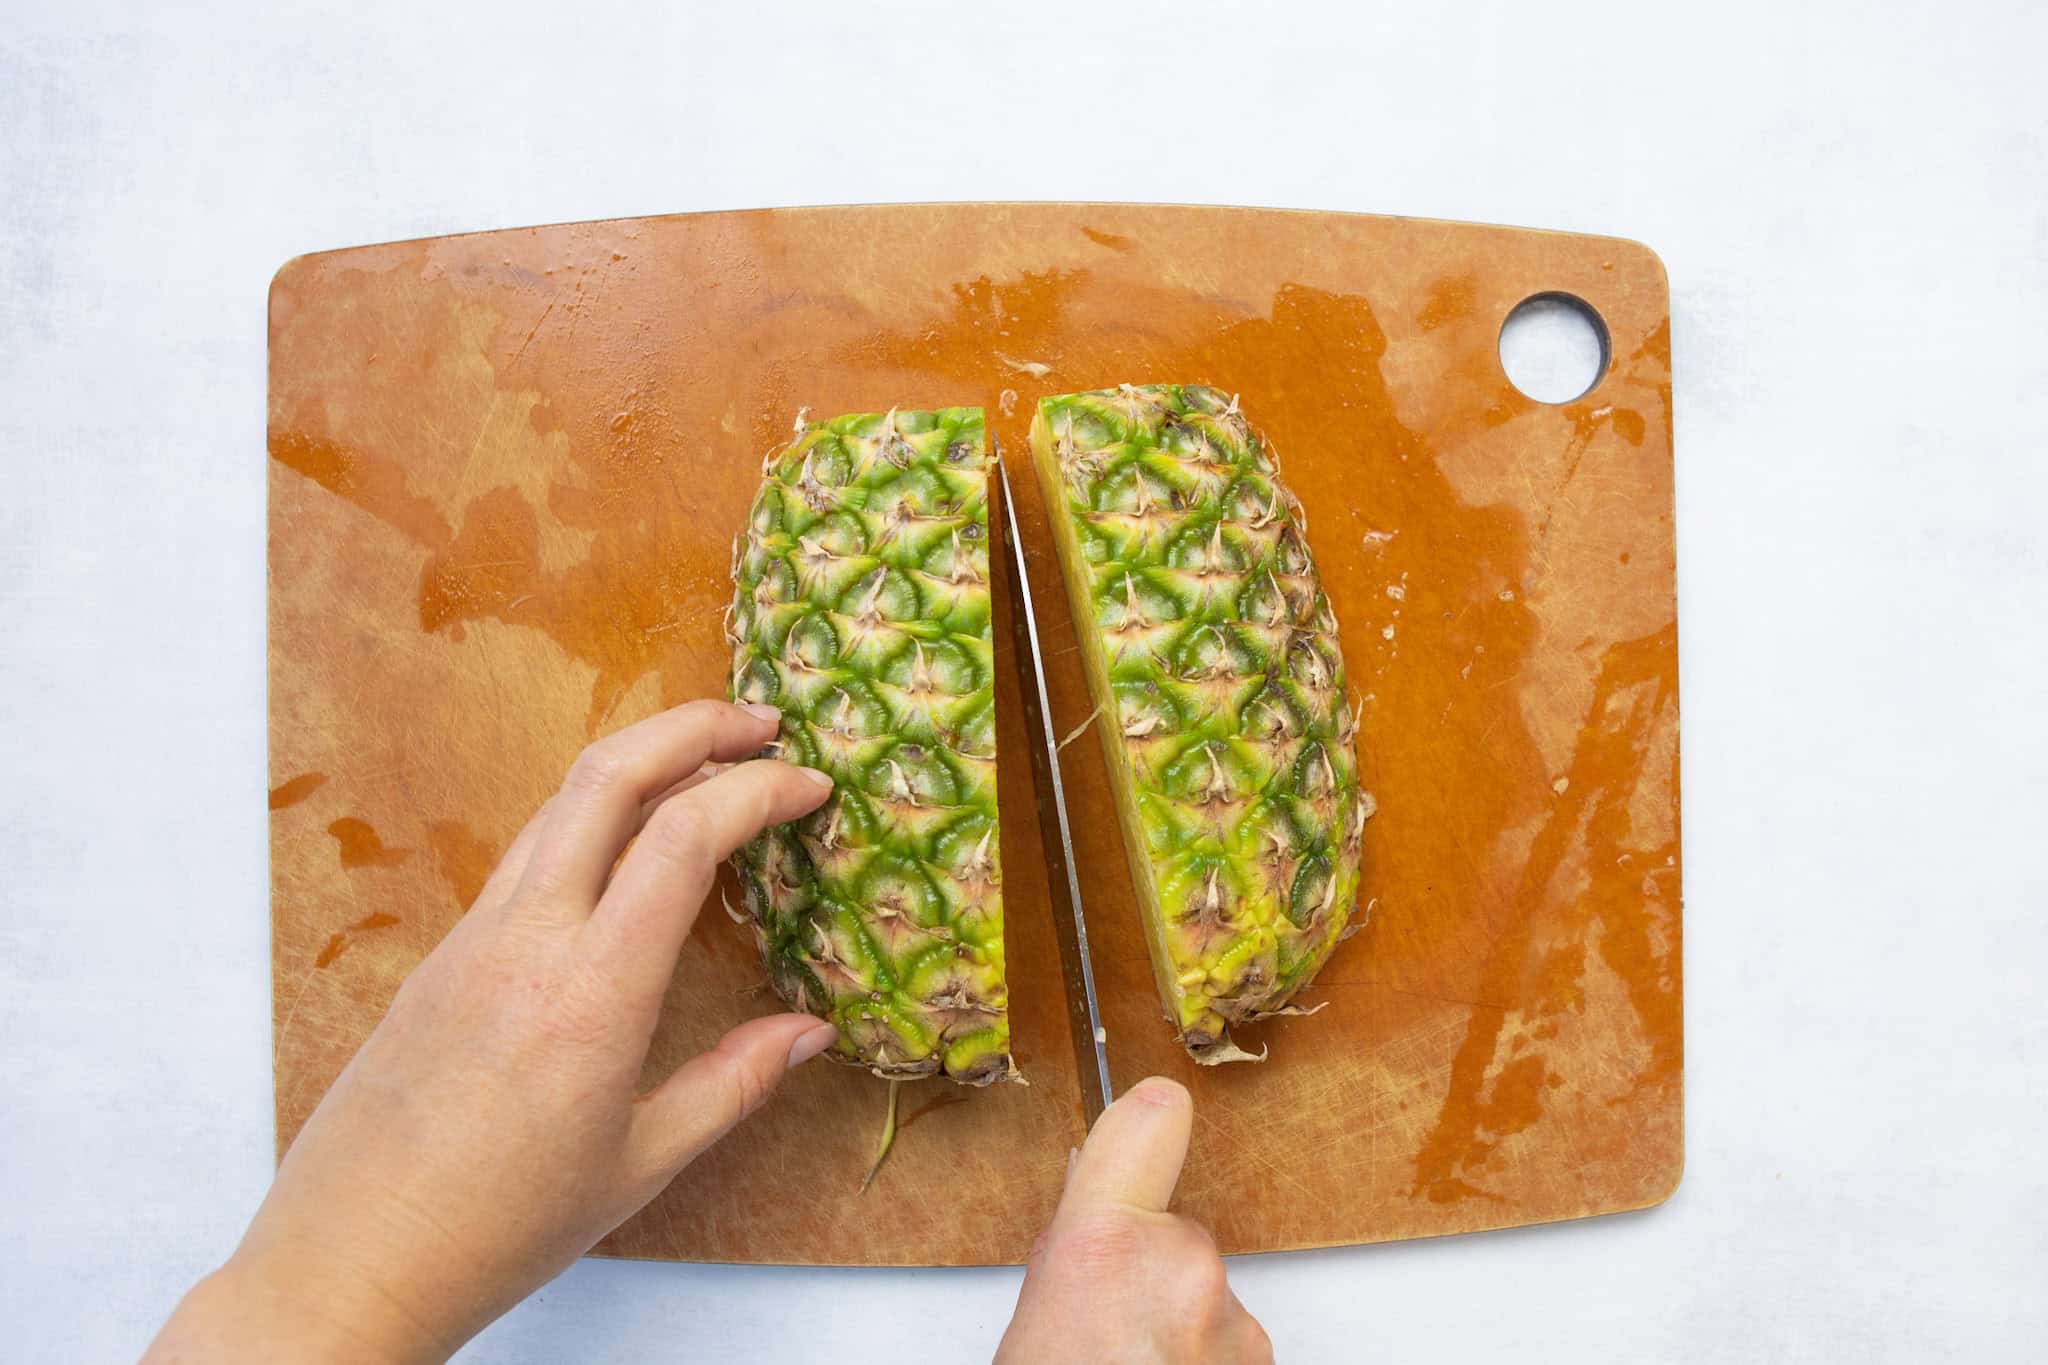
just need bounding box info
[1030,385,1372,1062]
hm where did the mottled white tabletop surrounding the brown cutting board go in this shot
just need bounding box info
[0,0,2048,1365]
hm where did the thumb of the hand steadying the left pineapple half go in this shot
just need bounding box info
[633,1015,840,1183]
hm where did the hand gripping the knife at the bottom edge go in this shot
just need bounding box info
[995,1076,1274,1365]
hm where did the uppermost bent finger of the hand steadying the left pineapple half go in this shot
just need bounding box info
[524,702,780,905]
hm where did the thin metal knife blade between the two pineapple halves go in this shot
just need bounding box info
[995,448,1110,1128]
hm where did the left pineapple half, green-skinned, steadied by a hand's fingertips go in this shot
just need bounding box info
[727,407,1014,1085]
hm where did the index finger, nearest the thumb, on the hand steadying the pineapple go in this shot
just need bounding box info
[588,759,831,995]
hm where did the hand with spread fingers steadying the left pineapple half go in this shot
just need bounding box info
[147,702,834,1361]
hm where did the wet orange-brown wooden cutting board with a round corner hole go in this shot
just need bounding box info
[268,205,1683,1265]
